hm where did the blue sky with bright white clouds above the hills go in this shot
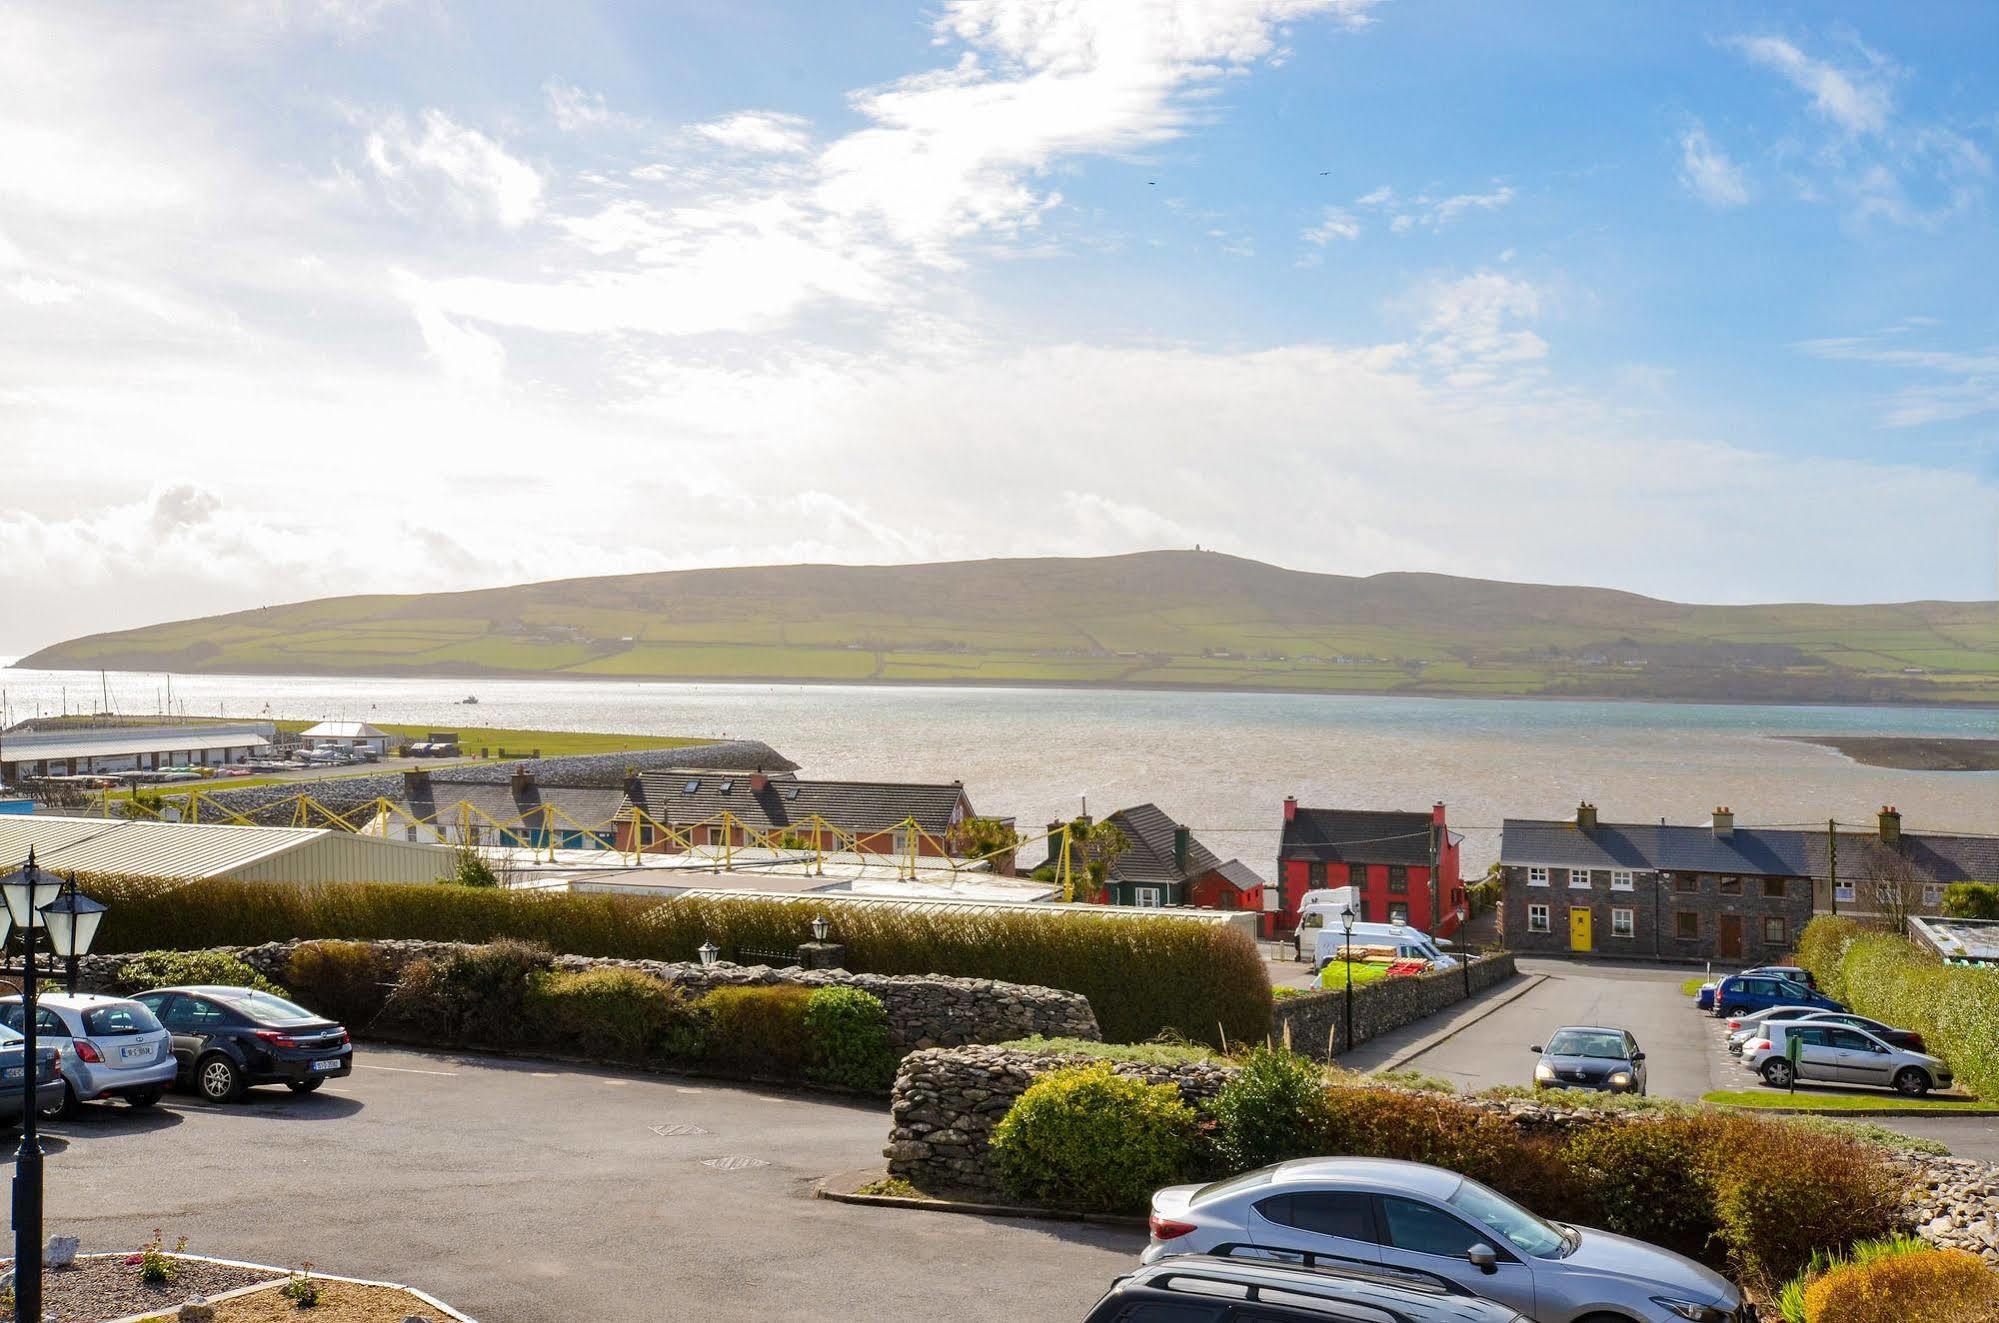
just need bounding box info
[0,0,1999,654]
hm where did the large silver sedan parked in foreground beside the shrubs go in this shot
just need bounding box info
[1143,1157,1755,1323]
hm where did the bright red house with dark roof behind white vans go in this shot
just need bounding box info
[1265,795,1465,937]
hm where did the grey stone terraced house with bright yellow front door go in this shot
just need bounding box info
[1499,803,1813,963]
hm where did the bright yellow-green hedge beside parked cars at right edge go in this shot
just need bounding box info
[1797,915,1999,1099]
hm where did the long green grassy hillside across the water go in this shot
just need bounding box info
[20,552,1999,703]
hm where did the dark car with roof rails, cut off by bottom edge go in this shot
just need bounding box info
[1085,1255,1533,1323]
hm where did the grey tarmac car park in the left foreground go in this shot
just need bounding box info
[11,1047,1143,1323]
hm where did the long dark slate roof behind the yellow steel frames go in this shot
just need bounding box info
[618,767,972,837]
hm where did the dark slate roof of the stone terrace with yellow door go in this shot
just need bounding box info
[1499,817,1813,877]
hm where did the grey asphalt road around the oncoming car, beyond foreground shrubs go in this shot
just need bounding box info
[1339,959,1999,1161]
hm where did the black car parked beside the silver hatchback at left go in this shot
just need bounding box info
[132,985,354,1103]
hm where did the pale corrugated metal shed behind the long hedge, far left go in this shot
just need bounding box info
[0,815,456,883]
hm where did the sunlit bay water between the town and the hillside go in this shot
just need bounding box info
[0,669,1999,873]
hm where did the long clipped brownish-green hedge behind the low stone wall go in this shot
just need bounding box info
[90,877,1271,1043]
